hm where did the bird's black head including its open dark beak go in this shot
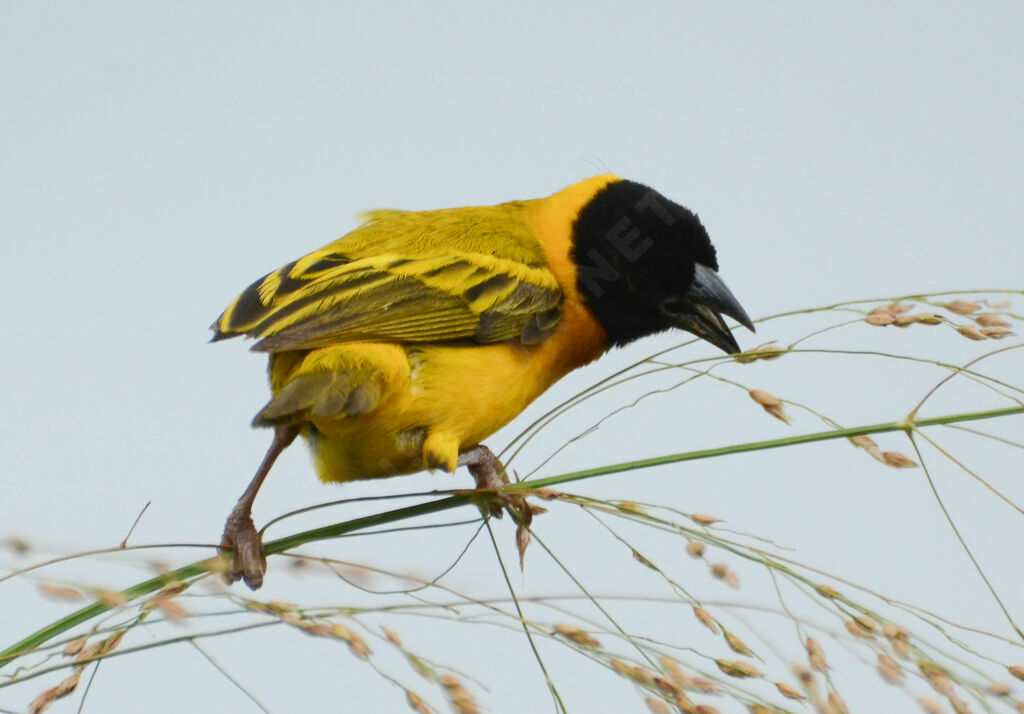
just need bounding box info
[572,180,754,353]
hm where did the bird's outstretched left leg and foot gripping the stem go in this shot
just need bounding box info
[220,424,299,590]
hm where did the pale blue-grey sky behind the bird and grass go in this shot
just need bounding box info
[0,1,1024,712]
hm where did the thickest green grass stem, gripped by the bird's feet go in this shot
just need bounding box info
[0,407,1024,668]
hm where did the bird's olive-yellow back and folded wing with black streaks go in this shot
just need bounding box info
[212,204,562,352]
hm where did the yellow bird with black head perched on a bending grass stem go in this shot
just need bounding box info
[211,174,754,590]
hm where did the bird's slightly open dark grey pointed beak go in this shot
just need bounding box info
[662,263,754,354]
